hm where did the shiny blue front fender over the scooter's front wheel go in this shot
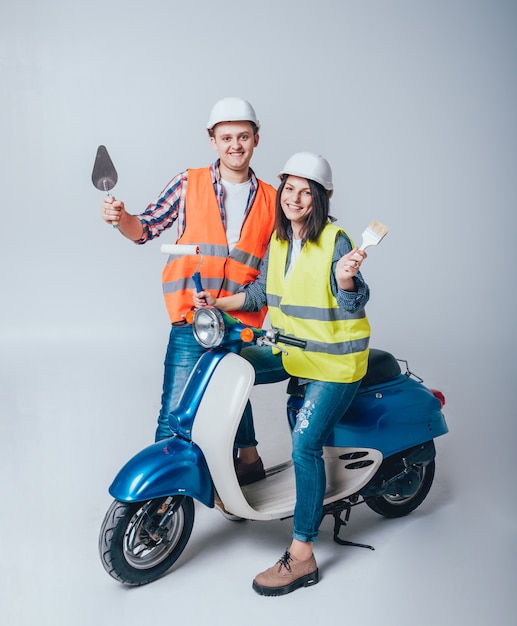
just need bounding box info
[109,437,214,507]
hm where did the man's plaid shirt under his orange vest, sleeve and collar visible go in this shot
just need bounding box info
[136,159,258,244]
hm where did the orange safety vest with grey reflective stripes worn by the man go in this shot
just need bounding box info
[162,168,276,327]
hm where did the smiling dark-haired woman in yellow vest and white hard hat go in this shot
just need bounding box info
[194,152,370,596]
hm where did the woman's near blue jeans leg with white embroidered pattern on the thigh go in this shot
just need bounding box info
[292,380,360,542]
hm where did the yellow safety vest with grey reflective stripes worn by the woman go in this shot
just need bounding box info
[266,224,370,382]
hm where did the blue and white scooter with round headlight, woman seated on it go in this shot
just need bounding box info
[99,307,448,586]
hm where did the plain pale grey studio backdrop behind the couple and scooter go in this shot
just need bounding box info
[0,0,517,626]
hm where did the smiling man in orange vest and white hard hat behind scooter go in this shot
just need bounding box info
[102,98,276,485]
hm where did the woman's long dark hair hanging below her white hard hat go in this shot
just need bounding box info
[275,174,330,242]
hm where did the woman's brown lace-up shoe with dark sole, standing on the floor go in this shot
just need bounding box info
[253,550,319,596]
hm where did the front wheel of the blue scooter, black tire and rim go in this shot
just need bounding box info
[99,496,194,586]
